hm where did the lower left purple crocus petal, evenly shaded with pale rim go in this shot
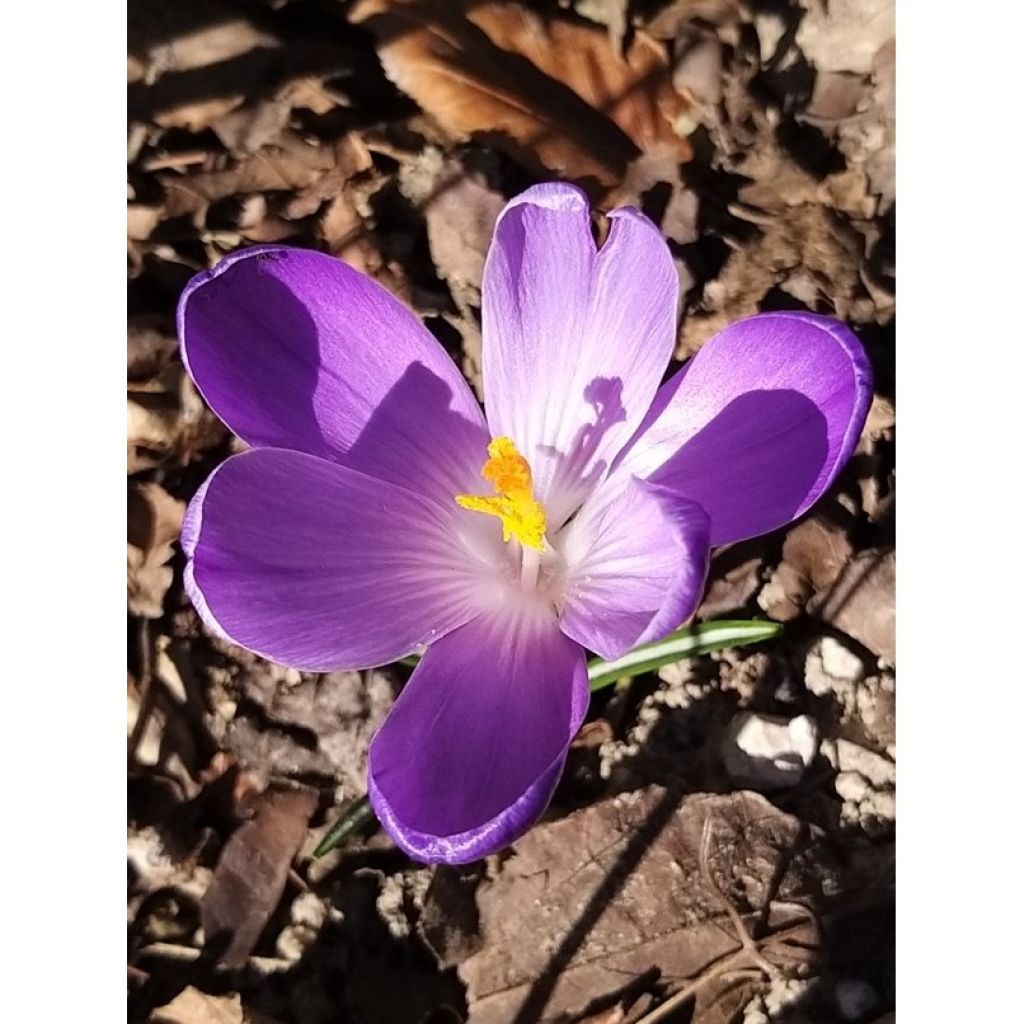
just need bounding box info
[182,449,493,672]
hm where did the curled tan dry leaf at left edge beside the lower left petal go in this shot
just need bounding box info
[128,481,185,618]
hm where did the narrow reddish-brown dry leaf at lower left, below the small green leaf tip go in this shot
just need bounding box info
[202,790,316,967]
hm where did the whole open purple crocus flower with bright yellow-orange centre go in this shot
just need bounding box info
[178,184,871,863]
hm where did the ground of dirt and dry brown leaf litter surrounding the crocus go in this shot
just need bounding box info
[127,0,896,1024]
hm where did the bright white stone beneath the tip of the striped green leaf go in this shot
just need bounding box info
[722,712,818,791]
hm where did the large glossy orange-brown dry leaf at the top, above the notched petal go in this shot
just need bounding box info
[350,0,692,187]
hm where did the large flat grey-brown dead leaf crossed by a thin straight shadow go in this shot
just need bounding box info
[424,786,820,1024]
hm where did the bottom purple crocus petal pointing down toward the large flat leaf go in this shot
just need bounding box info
[369,605,590,864]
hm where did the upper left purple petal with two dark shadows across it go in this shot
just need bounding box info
[178,246,487,501]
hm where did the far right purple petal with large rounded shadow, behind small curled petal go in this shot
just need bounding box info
[614,312,871,546]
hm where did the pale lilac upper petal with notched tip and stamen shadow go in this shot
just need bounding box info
[482,184,679,528]
